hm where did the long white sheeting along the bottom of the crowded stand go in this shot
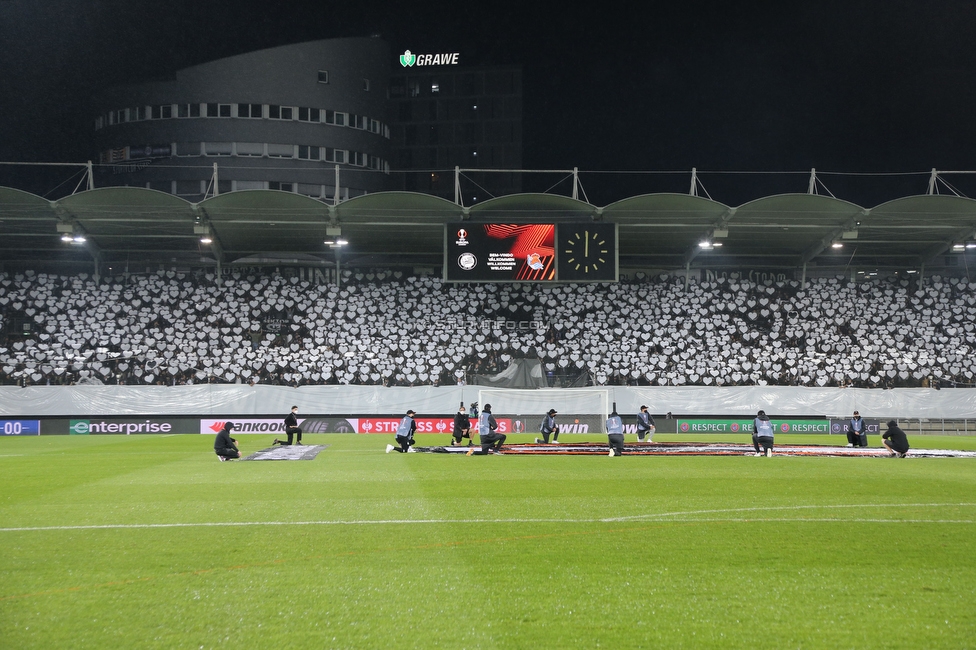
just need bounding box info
[0,384,976,419]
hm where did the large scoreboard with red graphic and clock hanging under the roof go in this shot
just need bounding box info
[444,223,618,282]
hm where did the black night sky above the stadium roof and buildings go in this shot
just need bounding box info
[0,0,976,202]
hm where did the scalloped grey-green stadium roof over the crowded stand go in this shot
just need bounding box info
[0,187,976,269]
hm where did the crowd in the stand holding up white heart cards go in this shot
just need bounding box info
[0,270,976,387]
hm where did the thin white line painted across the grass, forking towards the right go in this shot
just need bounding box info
[0,503,976,533]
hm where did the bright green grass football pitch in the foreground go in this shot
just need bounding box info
[0,435,976,649]
